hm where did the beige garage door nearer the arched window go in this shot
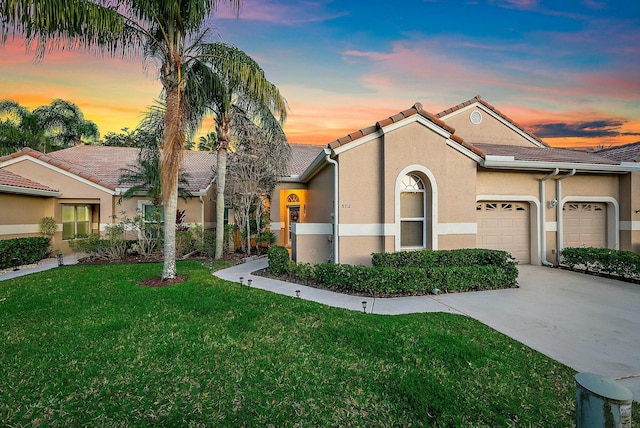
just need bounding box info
[476,202,531,264]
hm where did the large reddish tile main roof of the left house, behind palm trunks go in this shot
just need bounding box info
[0,146,216,192]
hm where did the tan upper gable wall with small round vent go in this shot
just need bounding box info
[445,108,535,147]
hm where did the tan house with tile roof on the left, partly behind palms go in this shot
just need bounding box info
[0,146,216,252]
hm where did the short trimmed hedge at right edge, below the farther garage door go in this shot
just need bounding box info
[559,247,640,279]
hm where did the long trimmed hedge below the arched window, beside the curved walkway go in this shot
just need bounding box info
[269,247,518,295]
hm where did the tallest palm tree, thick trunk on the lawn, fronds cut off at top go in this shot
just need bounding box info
[0,0,244,279]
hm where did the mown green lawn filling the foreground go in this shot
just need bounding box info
[0,262,616,427]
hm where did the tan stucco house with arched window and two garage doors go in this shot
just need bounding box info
[271,96,640,265]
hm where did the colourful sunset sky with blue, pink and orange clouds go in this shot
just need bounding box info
[0,0,640,147]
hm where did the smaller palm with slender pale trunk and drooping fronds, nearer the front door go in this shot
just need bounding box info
[208,43,287,259]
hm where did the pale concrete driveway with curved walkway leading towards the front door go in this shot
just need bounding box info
[214,259,640,401]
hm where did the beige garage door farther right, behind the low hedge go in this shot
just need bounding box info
[562,202,607,248]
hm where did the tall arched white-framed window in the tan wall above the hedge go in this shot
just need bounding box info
[400,174,427,248]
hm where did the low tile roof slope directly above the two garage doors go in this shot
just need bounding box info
[469,143,620,165]
